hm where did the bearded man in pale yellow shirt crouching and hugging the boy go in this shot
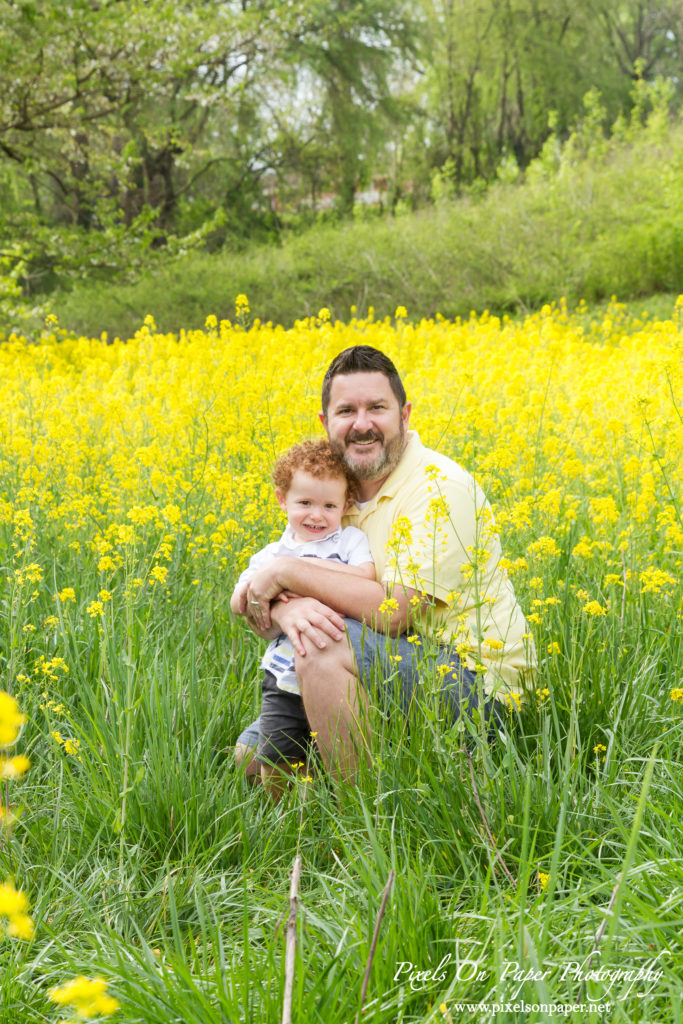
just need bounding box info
[237,345,536,779]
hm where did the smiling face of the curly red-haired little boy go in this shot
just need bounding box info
[275,469,350,544]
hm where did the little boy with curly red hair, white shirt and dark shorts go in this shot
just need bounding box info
[230,440,375,799]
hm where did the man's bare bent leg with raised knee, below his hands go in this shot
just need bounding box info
[296,640,370,783]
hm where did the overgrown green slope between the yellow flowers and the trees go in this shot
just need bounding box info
[48,111,683,336]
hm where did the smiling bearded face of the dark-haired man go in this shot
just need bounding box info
[321,372,411,480]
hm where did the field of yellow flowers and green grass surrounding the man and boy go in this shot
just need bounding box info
[0,297,683,1024]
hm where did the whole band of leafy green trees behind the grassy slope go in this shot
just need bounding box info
[0,0,683,328]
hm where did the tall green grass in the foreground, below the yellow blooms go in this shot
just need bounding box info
[0,565,683,1024]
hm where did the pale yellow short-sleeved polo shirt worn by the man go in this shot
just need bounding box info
[343,430,536,699]
